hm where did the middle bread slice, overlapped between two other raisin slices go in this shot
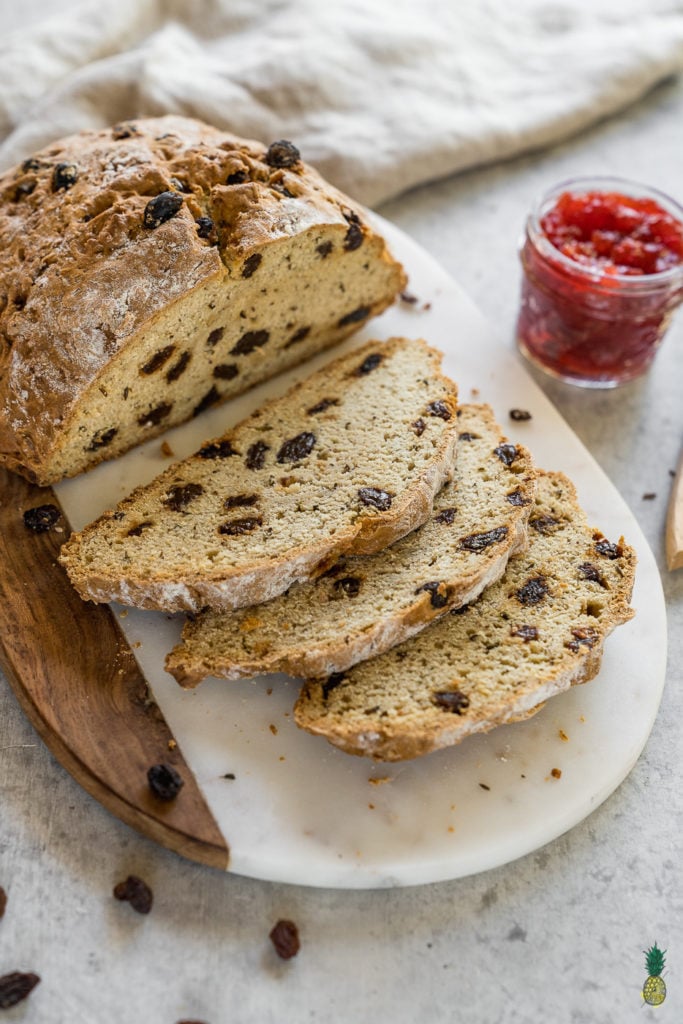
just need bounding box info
[166,406,536,687]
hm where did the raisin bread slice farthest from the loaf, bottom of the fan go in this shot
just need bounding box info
[295,473,636,761]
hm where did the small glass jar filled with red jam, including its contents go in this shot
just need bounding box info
[517,177,683,388]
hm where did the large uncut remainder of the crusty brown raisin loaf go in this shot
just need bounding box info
[0,117,404,484]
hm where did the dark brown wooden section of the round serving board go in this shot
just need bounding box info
[0,470,229,868]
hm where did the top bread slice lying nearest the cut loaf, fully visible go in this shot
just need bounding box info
[60,338,458,611]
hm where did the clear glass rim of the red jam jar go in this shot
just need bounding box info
[526,174,683,292]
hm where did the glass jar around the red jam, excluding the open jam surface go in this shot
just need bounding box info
[517,177,683,388]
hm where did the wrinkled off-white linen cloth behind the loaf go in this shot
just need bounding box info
[0,0,683,205]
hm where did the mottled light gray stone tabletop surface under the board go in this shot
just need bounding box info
[0,6,683,1024]
